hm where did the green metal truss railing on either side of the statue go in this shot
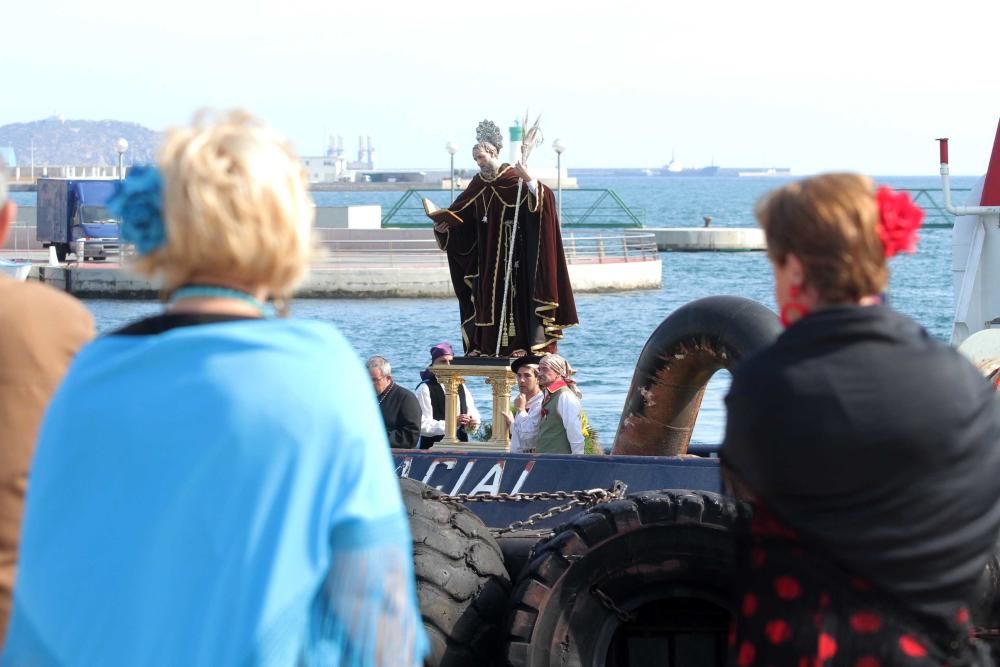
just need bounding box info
[382,188,646,228]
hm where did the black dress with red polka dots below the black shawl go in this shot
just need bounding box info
[729,504,992,667]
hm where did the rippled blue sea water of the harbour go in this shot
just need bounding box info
[66,176,974,447]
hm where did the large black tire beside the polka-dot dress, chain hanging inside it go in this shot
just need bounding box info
[506,490,749,667]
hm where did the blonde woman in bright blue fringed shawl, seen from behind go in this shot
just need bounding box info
[3,112,426,666]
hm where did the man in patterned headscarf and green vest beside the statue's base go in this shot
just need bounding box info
[536,354,584,454]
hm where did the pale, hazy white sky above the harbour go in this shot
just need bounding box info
[0,0,1000,175]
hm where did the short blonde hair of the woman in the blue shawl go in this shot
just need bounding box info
[135,110,316,299]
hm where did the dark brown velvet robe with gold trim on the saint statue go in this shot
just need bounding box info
[429,164,579,356]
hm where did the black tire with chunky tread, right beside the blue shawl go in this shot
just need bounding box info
[400,479,510,667]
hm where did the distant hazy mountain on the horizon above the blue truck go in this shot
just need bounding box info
[0,116,160,167]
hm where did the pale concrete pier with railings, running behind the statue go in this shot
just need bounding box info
[7,206,668,299]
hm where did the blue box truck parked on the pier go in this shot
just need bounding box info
[36,178,122,262]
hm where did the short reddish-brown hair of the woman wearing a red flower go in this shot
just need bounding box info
[755,174,889,303]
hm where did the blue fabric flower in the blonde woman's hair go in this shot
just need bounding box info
[108,166,167,256]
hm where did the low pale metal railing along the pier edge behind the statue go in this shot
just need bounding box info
[315,232,658,268]
